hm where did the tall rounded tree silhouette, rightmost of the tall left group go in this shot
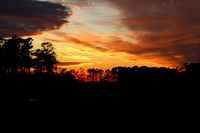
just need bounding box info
[32,42,58,74]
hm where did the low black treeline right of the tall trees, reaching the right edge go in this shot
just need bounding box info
[55,62,200,84]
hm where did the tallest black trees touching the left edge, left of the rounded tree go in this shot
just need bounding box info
[0,35,33,73]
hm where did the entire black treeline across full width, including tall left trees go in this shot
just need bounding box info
[0,35,200,84]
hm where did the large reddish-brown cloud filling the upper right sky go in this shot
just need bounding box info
[89,0,200,66]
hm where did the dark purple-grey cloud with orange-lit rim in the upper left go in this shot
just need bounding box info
[0,0,71,37]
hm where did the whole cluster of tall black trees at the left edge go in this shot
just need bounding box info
[0,35,58,74]
